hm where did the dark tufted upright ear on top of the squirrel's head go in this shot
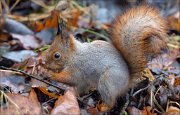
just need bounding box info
[57,18,69,39]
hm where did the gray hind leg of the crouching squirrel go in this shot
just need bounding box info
[98,68,129,107]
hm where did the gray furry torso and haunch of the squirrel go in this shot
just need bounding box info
[65,41,131,103]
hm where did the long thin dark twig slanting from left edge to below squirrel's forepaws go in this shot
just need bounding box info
[0,66,67,91]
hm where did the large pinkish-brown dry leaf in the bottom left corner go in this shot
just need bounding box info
[0,91,41,115]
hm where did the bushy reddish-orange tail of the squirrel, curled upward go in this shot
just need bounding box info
[111,6,167,74]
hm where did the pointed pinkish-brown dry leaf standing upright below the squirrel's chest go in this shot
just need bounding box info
[51,88,80,115]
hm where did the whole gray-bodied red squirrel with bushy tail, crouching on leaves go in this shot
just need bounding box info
[42,5,167,107]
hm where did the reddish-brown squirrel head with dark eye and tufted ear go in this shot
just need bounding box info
[42,19,75,72]
